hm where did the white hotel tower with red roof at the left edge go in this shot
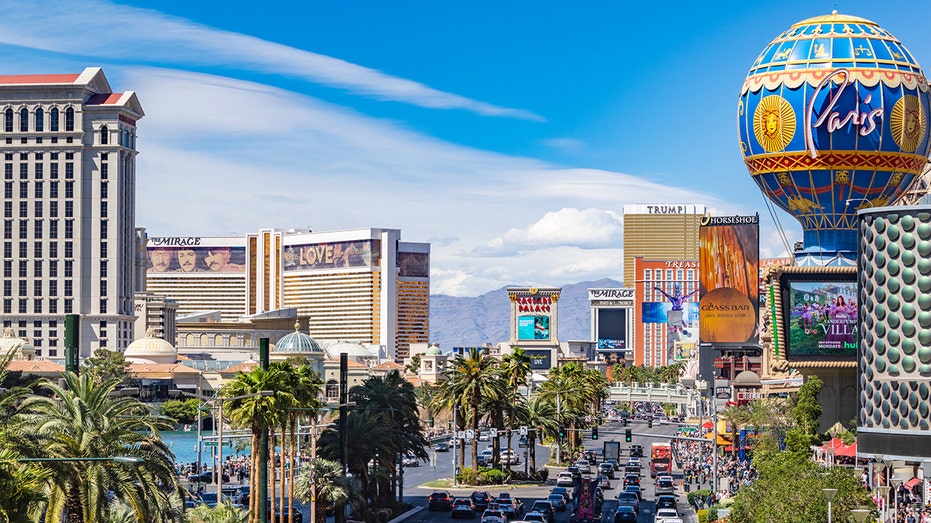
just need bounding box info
[0,68,144,358]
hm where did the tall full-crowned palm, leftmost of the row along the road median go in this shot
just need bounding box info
[443,347,506,467]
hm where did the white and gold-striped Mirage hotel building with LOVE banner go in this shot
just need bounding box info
[145,228,430,361]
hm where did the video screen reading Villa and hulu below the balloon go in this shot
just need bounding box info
[779,273,858,361]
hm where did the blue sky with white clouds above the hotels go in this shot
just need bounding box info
[0,0,931,296]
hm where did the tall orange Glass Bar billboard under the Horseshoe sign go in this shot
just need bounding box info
[698,215,760,346]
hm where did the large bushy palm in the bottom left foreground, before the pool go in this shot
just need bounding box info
[8,372,181,522]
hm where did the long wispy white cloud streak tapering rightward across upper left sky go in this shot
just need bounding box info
[0,0,543,121]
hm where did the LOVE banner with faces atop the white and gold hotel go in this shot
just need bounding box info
[284,240,381,271]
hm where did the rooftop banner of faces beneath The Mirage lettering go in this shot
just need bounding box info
[146,237,246,273]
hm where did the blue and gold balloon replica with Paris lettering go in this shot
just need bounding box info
[737,11,931,267]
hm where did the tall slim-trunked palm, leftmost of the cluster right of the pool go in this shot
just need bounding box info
[223,367,281,523]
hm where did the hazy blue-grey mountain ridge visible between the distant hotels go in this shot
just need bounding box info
[430,278,621,351]
